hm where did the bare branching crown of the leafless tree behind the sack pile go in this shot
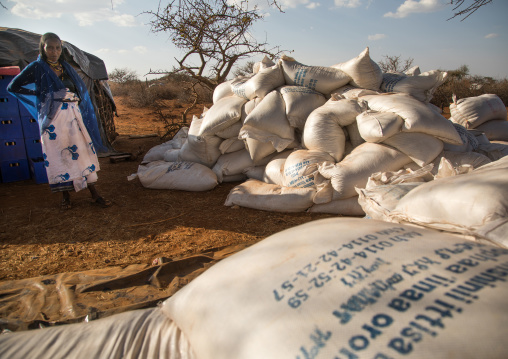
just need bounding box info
[146,0,280,90]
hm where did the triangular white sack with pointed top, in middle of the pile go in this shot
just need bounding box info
[239,91,295,152]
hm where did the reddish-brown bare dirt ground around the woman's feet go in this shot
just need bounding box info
[0,98,332,281]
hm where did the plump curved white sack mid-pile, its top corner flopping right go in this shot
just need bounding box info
[302,99,366,162]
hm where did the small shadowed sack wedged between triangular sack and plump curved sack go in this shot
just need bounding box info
[279,86,326,131]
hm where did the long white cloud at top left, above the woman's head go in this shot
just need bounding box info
[10,0,137,26]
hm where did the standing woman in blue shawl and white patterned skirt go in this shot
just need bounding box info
[7,33,111,210]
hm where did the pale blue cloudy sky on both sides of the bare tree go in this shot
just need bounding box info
[0,0,508,79]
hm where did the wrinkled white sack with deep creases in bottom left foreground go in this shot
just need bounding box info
[0,307,197,359]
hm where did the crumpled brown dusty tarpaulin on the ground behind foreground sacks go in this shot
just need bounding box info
[0,245,246,336]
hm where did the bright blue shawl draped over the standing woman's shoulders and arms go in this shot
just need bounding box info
[7,55,108,152]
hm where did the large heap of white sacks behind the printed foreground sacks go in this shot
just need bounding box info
[133,48,508,242]
